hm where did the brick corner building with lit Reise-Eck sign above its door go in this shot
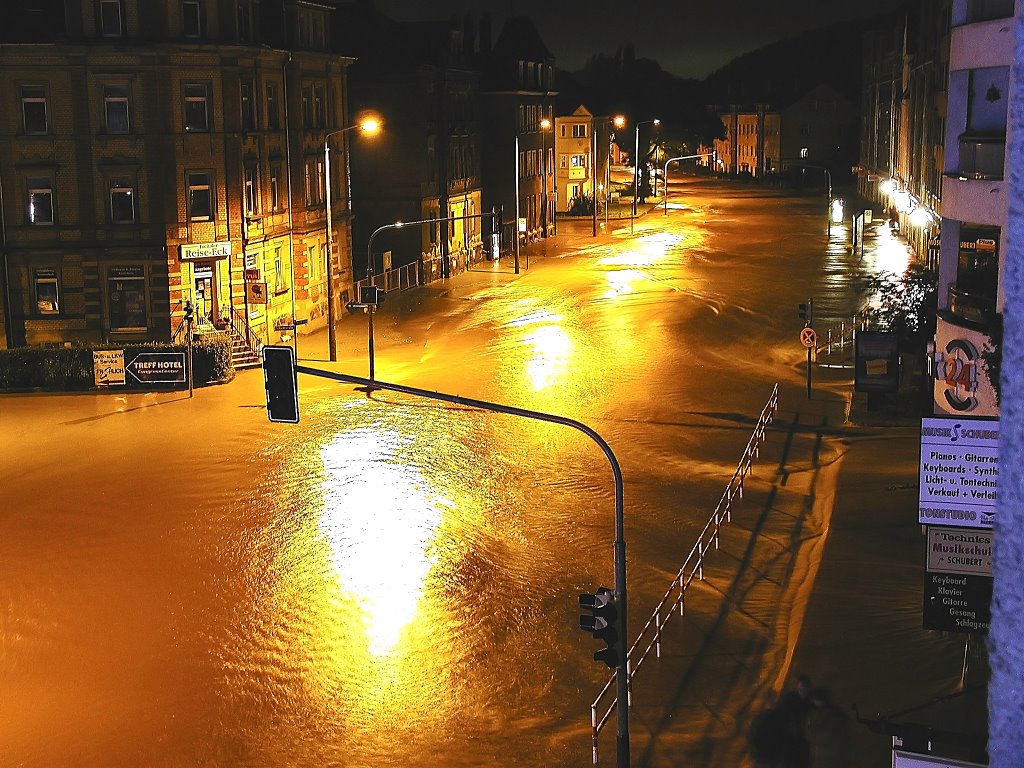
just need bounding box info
[0,0,351,346]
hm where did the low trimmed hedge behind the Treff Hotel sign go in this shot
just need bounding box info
[0,334,234,392]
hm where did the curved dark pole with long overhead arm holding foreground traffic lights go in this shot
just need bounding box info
[284,366,630,768]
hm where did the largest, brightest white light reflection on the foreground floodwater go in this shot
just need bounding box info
[319,429,452,655]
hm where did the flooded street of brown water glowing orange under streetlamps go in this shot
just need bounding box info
[0,180,907,768]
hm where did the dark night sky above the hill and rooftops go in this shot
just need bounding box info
[376,0,894,79]
